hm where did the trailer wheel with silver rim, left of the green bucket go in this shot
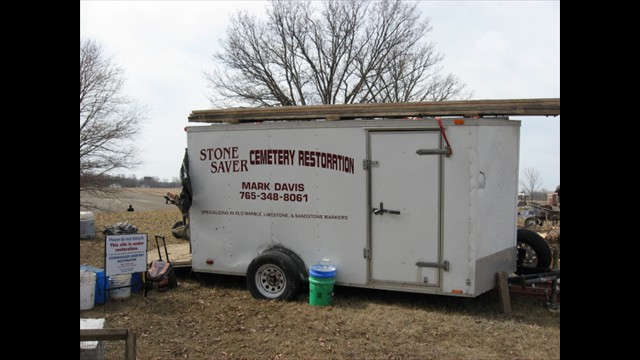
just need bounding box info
[247,251,302,300]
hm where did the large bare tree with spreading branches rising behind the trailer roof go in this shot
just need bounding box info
[205,0,471,107]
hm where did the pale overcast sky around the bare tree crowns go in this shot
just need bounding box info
[80,0,560,191]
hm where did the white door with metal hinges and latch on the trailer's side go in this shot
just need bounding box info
[369,130,442,287]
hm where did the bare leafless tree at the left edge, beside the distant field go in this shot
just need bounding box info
[80,39,146,207]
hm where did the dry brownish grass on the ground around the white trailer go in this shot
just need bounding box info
[80,207,560,359]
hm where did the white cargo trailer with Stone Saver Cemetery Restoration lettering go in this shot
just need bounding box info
[176,100,560,299]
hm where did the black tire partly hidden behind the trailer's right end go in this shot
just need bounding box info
[516,229,551,275]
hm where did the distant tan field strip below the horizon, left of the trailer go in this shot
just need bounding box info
[80,188,180,213]
